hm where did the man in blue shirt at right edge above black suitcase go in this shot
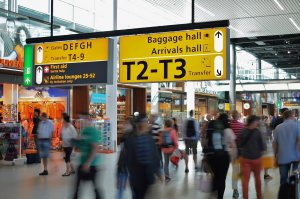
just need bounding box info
[273,110,300,184]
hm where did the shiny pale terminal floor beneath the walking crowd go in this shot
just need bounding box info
[0,148,279,199]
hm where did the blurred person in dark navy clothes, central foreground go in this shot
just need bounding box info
[124,115,160,199]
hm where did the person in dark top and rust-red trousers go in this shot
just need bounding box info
[240,115,265,199]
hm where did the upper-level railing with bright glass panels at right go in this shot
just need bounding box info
[237,67,300,80]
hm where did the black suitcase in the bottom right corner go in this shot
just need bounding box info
[278,170,300,199]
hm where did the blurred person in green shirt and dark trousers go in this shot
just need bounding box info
[72,113,102,199]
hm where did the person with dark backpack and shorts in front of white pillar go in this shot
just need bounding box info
[183,110,199,173]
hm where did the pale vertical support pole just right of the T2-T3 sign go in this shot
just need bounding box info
[229,44,236,111]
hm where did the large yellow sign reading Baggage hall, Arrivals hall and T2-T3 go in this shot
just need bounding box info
[119,28,229,83]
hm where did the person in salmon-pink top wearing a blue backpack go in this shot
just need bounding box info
[160,119,178,182]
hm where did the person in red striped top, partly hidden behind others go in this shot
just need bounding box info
[230,110,245,198]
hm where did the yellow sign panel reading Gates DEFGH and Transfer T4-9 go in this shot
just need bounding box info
[34,38,108,65]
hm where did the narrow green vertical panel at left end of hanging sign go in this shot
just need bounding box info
[23,45,34,86]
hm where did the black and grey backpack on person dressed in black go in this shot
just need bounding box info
[206,120,225,153]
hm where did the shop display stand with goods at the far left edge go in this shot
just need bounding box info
[0,123,26,165]
